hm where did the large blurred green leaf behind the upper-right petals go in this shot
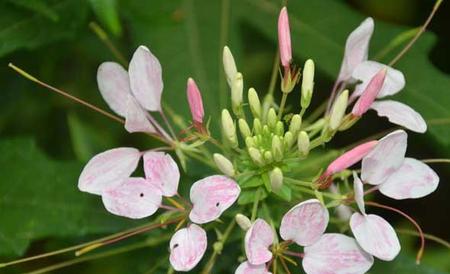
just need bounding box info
[239,0,450,151]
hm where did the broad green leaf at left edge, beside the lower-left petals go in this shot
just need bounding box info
[0,139,142,256]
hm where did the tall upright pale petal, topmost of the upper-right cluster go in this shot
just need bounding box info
[338,17,374,82]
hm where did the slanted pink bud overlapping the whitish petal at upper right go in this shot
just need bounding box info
[352,68,387,117]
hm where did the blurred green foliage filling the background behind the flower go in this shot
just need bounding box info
[0,0,450,273]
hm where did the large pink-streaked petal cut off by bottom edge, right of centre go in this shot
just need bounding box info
[302,233,373,274]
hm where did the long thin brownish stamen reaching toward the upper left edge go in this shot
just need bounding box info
[8,63,125,124]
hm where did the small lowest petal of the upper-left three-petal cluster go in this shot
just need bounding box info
[125,95,156,133]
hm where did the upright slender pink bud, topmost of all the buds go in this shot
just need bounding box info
[278,7,292,68]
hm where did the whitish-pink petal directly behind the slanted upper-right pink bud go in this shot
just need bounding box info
[352,61,405,98]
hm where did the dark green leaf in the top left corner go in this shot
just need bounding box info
[0,0,87,56]
